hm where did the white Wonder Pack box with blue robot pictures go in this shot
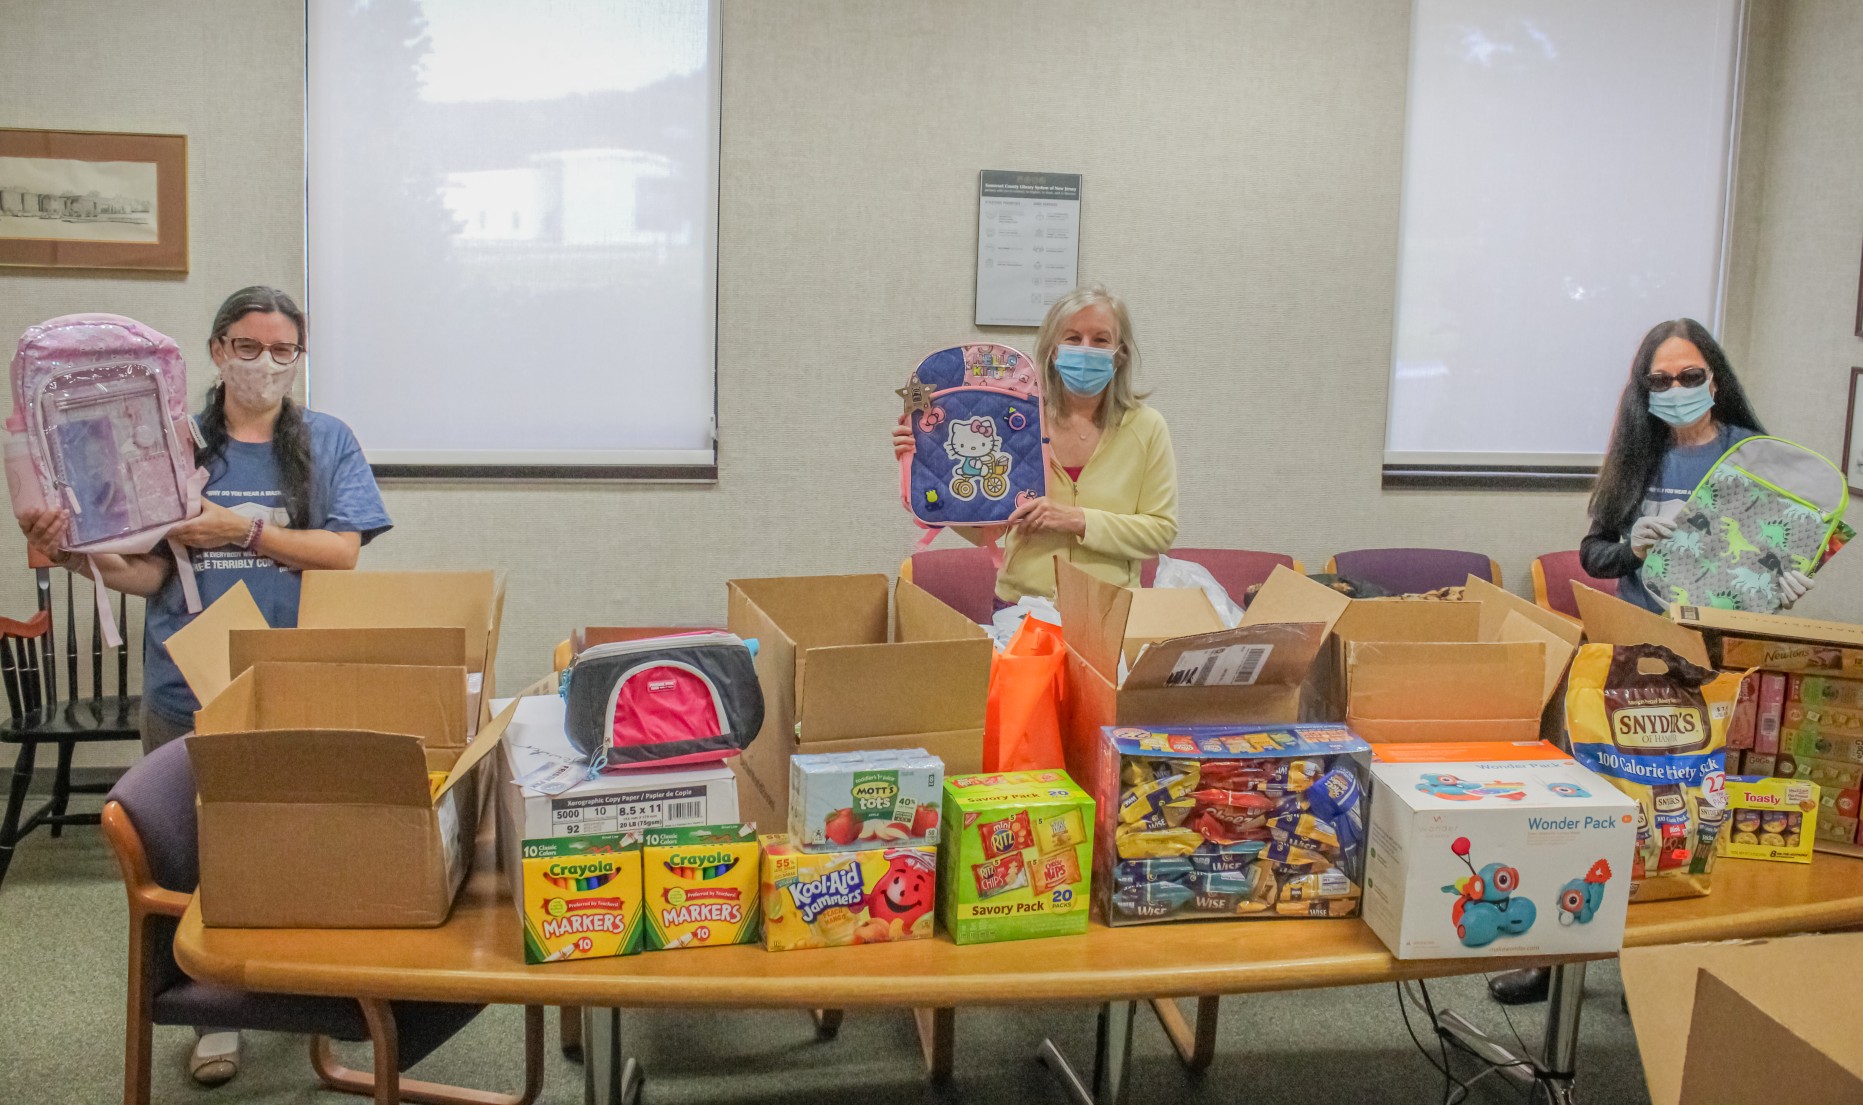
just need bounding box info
[1364,742,1636,960]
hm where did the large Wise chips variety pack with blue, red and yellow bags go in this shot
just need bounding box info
[1094,725,1369,924]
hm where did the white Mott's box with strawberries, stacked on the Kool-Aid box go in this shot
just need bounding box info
[790,749,945,852]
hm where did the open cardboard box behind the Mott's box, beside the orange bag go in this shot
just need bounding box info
[727,576,991,829]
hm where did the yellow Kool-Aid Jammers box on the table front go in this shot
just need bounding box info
[762,833,937,952]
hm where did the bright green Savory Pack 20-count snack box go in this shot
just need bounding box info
[937,771,1094,945]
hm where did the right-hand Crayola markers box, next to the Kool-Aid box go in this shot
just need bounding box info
[641,825,762,950]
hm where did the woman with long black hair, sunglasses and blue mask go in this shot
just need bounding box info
[1580,319,1811,613]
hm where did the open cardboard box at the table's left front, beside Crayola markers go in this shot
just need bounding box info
[188,663,514,928]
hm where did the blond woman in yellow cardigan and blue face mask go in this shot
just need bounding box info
[892,285,1177,606]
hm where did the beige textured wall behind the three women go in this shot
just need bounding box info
[0,0,1863,763]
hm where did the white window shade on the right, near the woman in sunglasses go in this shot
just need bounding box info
[1384,0,1742,471]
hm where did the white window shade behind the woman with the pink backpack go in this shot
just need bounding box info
[306,0,719,469]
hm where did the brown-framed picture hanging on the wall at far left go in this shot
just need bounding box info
[0,127,188,272]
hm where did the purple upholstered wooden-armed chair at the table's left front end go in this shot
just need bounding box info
[102,738,544,1105]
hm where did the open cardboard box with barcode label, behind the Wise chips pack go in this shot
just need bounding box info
[1058,561,1343,779]
